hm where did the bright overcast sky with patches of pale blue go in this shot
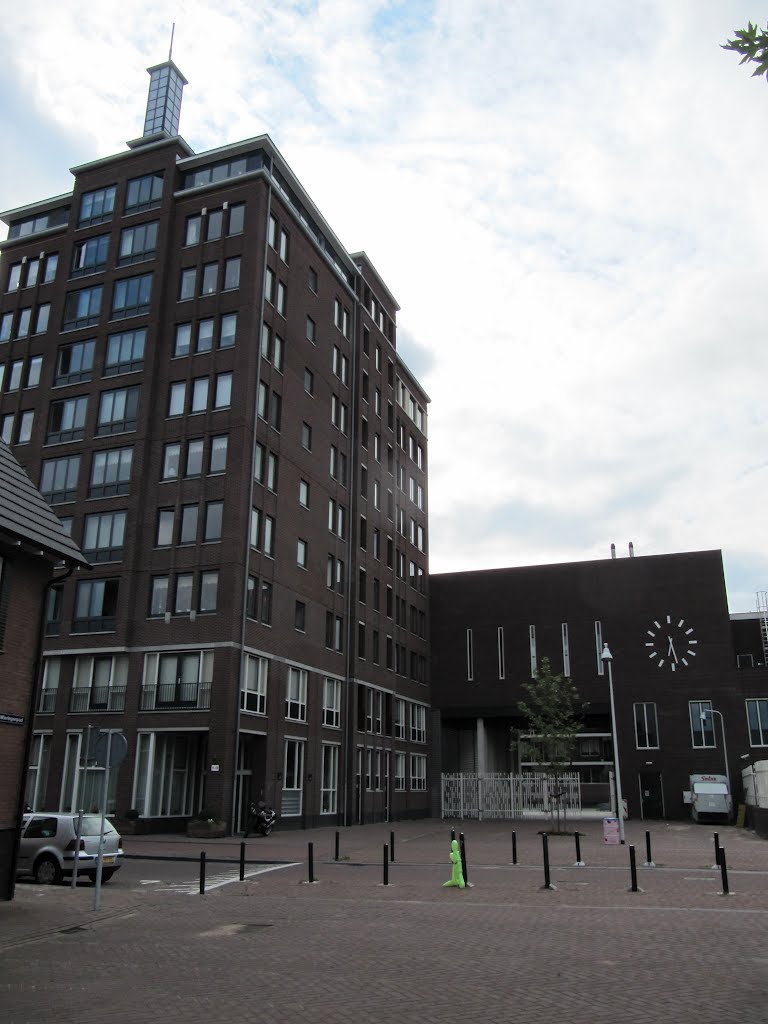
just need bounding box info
[0,0,768,611]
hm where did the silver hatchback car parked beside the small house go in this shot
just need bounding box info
[16,811,123,885]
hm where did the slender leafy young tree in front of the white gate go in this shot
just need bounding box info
[519,657,587,826]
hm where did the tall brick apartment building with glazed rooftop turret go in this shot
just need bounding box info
[0,60,429,829]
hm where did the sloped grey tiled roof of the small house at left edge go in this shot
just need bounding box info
[0,440,89,565]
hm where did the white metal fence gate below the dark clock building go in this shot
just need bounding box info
[441,772,582,820]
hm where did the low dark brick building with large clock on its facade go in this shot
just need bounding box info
[430,551,768,818]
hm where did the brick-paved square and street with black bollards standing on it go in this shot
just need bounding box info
[0,821,768,1024]
